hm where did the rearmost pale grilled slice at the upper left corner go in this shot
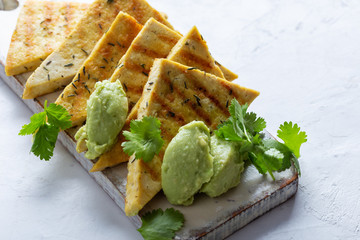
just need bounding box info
[5,0,89,76]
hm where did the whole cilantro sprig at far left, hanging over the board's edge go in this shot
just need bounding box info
[19,101,72,161]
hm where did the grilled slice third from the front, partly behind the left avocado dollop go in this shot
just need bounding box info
[90,18,181,172]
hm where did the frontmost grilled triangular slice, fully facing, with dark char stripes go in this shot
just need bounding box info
[125,59,259,216]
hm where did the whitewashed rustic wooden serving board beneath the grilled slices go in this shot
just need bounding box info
[0,1,298,239]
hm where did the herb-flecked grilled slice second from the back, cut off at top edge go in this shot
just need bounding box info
[23,0,171,99]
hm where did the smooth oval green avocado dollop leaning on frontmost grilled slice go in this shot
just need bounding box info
[161,121,213,205]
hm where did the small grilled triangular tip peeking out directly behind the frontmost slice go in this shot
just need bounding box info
[167,26,224,78]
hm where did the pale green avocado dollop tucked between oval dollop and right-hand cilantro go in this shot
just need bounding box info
[200,135,244,197]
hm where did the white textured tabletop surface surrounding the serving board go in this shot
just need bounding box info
[0,0,360,240]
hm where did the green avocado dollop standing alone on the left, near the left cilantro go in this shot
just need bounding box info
[75,80,128,159]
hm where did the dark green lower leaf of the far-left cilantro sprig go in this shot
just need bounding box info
[31,124,59,161]
